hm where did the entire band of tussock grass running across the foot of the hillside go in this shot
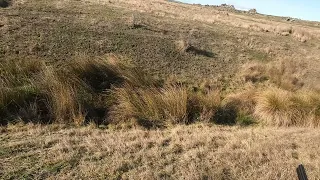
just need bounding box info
[0,56,320,128]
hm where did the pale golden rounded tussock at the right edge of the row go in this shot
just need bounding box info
[254,88,320,127]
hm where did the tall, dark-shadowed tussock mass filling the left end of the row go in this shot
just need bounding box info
[0,58,125,124]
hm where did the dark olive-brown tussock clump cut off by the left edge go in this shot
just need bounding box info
[0,59,45,124]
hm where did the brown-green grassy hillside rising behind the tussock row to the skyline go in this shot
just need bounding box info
[0,0,320,89]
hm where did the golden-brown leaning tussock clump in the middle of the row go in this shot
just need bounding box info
[109,84,187,127]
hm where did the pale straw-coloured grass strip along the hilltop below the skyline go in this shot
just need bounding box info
[99,0,320,42]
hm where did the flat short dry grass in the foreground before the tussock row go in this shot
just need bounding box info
[0,124,320,180]
